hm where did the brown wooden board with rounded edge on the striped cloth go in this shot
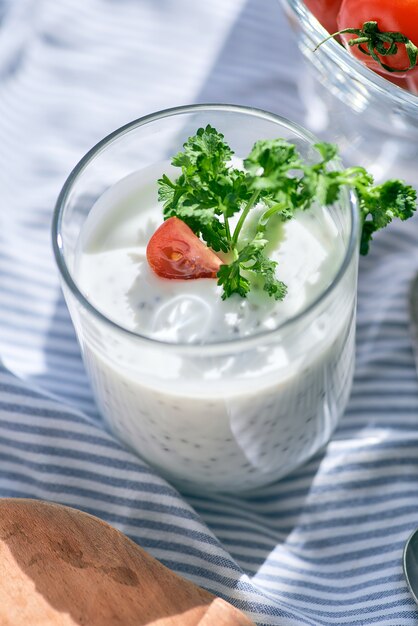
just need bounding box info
[0,499,254,626]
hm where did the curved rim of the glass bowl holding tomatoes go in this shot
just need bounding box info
[281,0,418,110]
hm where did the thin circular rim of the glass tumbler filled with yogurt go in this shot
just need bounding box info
[51,103,360,352]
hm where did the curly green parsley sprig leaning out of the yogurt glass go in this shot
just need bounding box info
[158,125,416,300]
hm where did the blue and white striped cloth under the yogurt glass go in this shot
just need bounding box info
[0,0,418,626]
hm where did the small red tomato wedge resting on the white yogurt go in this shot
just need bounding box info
[147,217,222,280]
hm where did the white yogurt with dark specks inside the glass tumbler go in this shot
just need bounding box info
[73,165,356,490]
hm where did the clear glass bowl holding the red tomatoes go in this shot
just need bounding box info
[282,0,418,184]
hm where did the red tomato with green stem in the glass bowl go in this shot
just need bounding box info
[337,0,418,77]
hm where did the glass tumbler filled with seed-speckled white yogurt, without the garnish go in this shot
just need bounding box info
[53,105,358,492]
